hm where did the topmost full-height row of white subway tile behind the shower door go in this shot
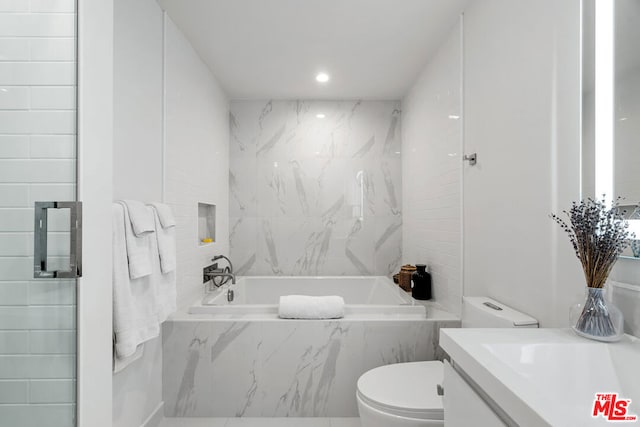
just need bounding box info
[0,14,75,37]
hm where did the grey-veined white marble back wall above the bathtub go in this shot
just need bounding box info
[229,101,402,276]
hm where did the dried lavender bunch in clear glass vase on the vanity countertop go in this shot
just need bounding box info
[551,198,635,341]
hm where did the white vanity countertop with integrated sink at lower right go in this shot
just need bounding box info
[440,328,640,427]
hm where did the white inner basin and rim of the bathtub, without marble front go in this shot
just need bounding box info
[189,276,438,319]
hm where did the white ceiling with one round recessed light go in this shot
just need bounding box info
[158,0,468,99]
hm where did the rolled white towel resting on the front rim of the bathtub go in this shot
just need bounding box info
[278,295,344,319]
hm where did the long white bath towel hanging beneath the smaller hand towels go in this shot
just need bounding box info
[112,203,160,359]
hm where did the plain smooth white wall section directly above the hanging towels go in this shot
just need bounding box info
[113,0,163,202]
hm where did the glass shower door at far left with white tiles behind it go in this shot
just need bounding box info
[0,0,80,427]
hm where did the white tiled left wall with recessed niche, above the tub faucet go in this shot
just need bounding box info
[165,18,229,307]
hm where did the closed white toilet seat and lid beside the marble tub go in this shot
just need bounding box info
[357,361,444,420]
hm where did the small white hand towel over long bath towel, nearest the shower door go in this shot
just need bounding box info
[117,201,155,280]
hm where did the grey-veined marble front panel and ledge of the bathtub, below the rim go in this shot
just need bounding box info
[163,312,460,417]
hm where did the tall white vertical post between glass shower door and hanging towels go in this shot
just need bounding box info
[76,0,114,427]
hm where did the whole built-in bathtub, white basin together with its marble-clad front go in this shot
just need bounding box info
[162,277,460,417]
